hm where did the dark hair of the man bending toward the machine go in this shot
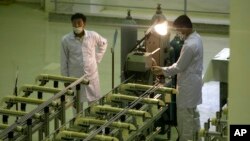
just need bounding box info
[173,15,193,28]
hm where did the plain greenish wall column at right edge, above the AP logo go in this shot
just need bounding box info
[228,0,250,125]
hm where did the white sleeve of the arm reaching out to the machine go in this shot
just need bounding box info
[163,45,193,76]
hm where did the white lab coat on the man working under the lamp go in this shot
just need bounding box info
[163,32,203,108]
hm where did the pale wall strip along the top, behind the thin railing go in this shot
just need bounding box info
[44,0,229,13]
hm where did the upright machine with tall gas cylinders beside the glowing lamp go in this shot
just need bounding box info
[121,4,178,139]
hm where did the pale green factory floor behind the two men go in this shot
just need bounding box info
[0,3,229,140]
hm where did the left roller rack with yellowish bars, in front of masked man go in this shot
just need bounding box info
[0,74,88,140]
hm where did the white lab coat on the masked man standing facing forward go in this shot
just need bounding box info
[61,30,107,102]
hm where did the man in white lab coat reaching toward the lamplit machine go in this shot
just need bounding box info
[152,15,203,141]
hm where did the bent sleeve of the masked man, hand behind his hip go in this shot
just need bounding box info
[96,34,108,63]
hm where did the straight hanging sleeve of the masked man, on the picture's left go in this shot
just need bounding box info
[61,40,69,76]
